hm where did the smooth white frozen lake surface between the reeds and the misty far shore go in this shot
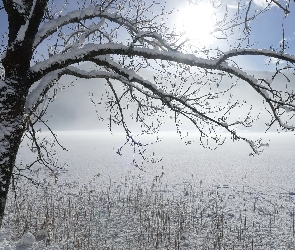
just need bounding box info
[18,132,295,193]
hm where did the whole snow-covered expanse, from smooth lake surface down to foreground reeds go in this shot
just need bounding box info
[0,134,295,249]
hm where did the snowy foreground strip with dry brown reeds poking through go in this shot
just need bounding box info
[0,175,295,250]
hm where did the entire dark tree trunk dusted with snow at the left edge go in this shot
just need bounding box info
[0,0,47,226]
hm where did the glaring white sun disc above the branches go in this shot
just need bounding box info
[177,3,216,45]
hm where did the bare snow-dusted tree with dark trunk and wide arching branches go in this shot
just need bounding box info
[0,0,295,227]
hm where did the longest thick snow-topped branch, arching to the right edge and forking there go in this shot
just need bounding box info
[31,43,294,133]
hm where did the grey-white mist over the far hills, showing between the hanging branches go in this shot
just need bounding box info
[34,63,295,135]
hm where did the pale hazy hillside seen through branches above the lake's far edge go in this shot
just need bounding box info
[34,63,295,132]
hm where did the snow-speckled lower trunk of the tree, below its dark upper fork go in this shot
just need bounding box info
[0,80,27,227]
